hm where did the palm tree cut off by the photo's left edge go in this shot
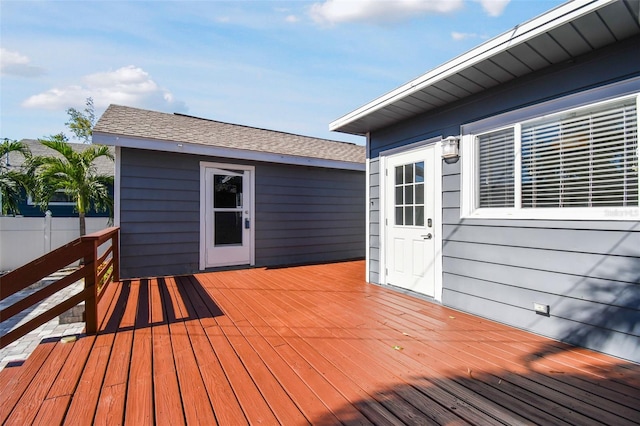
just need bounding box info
[0,139,31,215]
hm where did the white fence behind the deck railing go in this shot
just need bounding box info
[0,216,108,271]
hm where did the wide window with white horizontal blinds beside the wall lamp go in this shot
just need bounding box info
[473,96,640,217]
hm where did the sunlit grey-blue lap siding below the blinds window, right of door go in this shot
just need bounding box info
[442,161,640,362]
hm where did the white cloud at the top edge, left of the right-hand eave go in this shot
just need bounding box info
[309,0,463,24]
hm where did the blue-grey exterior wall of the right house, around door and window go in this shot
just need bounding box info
[368,37,640,362]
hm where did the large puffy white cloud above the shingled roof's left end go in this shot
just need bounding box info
[22,65,186,112]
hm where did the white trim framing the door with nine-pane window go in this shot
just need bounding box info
[379,138,442,302]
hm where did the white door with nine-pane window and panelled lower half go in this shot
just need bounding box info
[385,146,436,297]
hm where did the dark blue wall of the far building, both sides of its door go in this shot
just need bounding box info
[120,148,365,278]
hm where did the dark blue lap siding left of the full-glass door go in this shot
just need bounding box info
[120,148,200,278]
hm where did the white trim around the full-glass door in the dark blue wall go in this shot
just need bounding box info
[199,161,256,271]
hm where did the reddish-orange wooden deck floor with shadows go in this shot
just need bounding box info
[0,262,640,425]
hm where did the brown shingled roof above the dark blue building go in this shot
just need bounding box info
[93,105,365,164]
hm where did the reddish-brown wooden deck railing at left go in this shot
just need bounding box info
[0,227,120,348]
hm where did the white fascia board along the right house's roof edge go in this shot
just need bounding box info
[329,0,618,131]
